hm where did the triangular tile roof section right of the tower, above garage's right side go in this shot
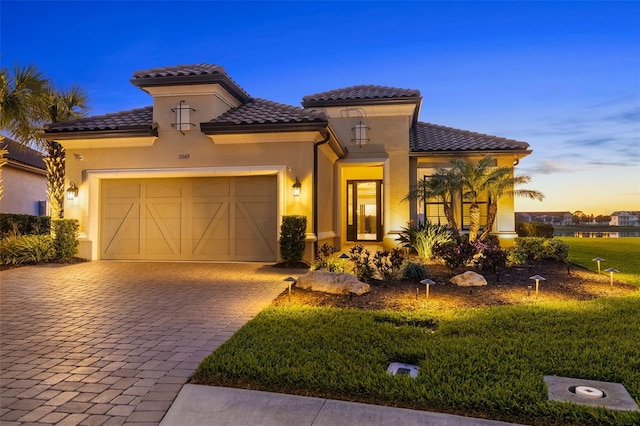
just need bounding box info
[203,98,328,127]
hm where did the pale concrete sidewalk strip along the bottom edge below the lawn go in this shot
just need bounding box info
[160,384,524,426]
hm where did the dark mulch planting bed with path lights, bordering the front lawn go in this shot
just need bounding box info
[274,263,638,310]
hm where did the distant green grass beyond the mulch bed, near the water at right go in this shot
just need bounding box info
[555,237,640,287]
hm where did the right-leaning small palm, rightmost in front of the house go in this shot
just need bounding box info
[478,167,544,241]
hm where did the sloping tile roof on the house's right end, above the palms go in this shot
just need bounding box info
[409,122,529,152]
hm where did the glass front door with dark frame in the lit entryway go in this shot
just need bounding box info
[347,180,383,241]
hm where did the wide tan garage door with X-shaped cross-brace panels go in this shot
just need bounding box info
[100,176,277,262]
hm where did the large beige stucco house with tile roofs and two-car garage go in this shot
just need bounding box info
[44,64,531,262]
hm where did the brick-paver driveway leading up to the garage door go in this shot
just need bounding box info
[0,261,299,426]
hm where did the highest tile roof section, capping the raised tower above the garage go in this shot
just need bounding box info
[130,64,251,102]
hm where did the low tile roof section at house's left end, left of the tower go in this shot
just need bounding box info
[45,106,153,134]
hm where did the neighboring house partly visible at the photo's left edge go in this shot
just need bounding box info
[0,137,48,216]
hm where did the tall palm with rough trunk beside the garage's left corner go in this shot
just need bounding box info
[37,85,88,219]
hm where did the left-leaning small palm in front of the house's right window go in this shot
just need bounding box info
[404,169,459,233]
